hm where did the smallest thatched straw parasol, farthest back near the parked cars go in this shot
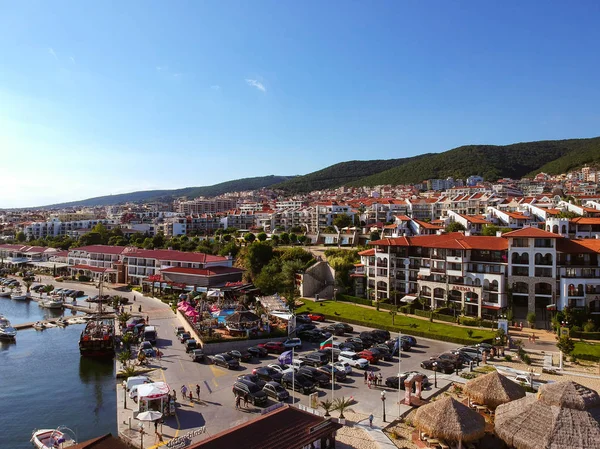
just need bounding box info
[465,371,525,408]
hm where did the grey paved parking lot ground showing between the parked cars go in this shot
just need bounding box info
[132,316,464,441]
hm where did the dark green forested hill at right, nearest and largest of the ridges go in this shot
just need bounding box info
[350,137,600,186]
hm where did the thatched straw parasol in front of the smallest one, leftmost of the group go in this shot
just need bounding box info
[414,396,485,445]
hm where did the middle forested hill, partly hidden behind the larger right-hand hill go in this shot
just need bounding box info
[273,154,428,193]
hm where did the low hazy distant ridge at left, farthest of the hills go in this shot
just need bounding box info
[37,175,291,208]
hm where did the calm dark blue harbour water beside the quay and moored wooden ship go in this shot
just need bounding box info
[0,298,117,449]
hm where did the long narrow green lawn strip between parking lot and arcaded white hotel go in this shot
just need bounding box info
[296,299,494,344]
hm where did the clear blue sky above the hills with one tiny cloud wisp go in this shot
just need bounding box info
[0,0,600,207]
